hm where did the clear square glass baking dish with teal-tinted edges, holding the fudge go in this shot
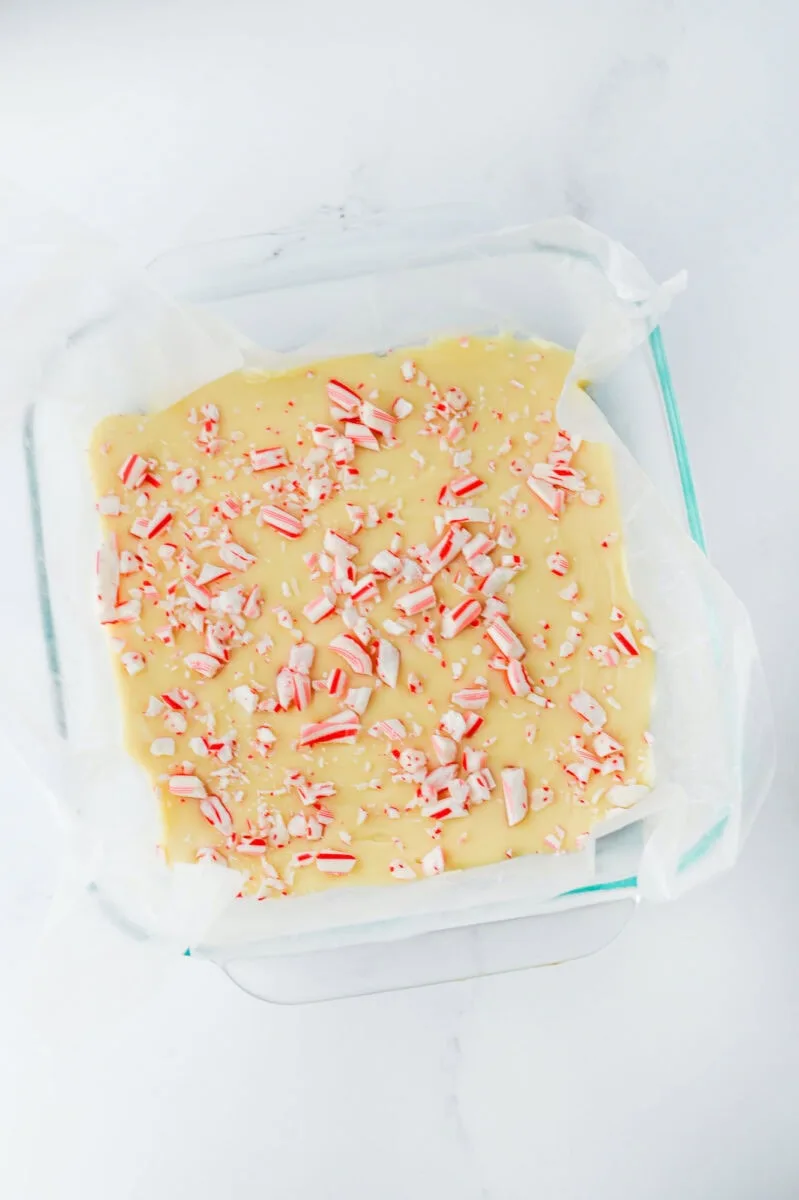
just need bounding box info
[24,206,758,1002]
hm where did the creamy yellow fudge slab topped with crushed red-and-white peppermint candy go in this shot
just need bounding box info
[90,336,655,899]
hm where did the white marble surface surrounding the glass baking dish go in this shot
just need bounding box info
[0,0,799,1200]
